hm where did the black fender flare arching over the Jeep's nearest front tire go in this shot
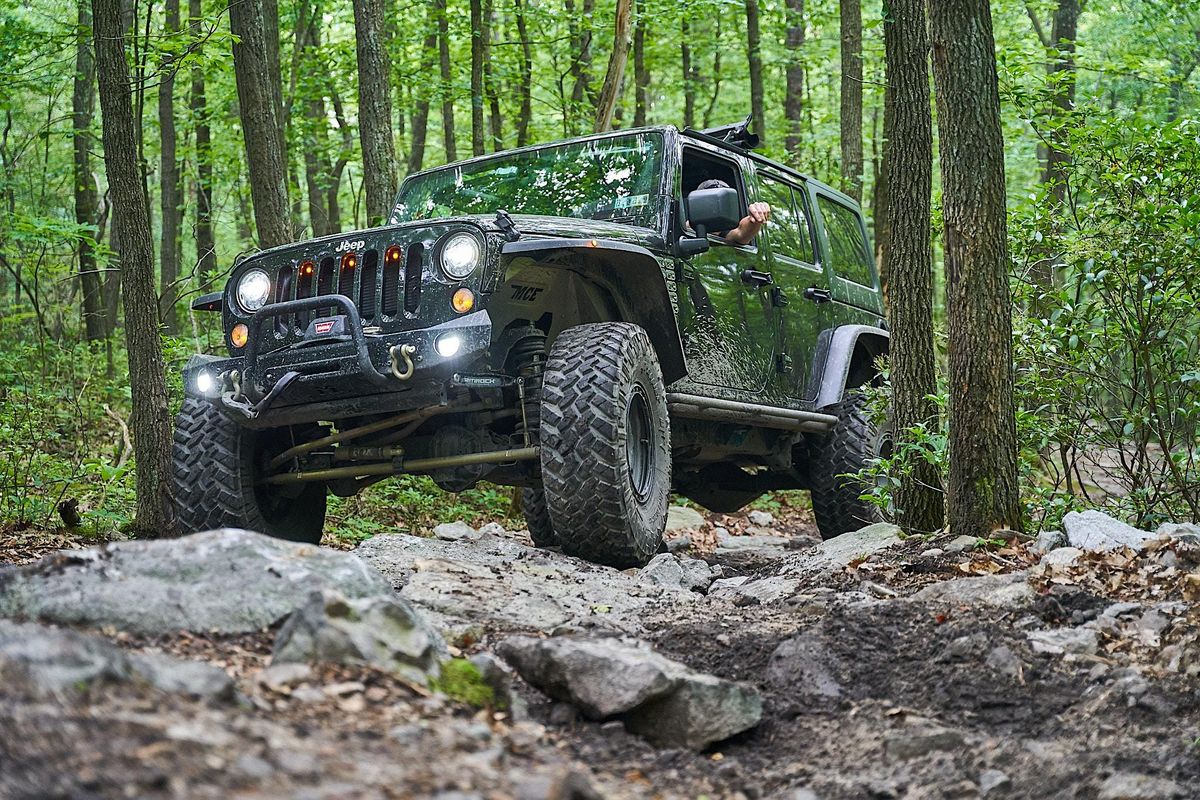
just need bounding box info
[500,239,688,385]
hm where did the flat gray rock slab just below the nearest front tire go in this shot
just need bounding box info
[355,534,666,633]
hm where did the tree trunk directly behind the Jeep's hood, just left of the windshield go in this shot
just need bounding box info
[354,0,396,225]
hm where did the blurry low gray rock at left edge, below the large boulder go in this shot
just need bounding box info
[0,620,234,700]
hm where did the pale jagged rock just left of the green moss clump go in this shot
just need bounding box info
[271,591,449,685]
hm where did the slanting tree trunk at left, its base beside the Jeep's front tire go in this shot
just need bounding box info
[92,0,175,537]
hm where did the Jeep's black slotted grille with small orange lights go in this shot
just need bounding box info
[274,242,425,337]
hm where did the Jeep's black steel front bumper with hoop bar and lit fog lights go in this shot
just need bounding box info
[184,295,492,427]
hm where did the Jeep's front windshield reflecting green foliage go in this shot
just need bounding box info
[390,132,662,228]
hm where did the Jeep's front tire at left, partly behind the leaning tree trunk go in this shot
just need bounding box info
[172,397,325,545]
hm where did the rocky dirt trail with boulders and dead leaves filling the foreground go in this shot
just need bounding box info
[0,509,1200,800]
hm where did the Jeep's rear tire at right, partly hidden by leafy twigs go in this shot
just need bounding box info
[809,391,892,539]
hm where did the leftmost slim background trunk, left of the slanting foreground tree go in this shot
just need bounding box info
[71,0,108,342]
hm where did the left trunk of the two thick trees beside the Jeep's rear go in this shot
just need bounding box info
[876,0,943,533]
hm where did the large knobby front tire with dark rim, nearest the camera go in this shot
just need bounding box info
[539,323,671,569]
